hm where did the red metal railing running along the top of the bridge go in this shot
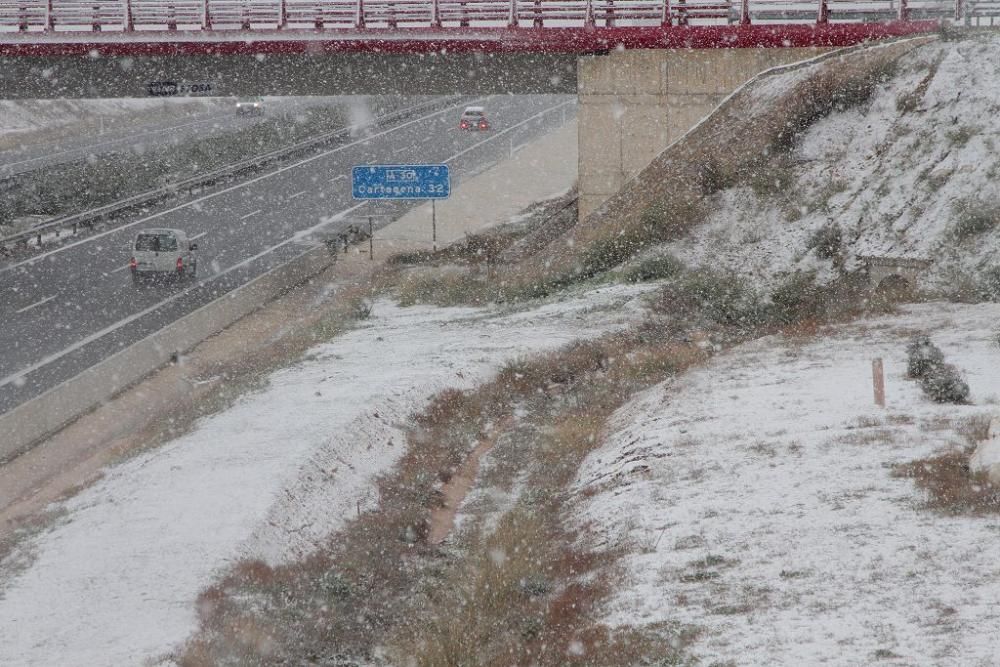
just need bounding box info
[0,0,1000,33]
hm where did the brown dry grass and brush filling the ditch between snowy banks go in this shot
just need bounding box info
[177,249,892,667]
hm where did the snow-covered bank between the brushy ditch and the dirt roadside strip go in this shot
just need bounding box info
[0,286,649,667]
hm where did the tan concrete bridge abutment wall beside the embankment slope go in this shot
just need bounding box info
[577,47,829,220]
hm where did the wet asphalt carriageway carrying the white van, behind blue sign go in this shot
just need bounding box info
[0,96,575,414]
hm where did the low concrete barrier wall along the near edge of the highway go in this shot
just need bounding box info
[0,246,334,462]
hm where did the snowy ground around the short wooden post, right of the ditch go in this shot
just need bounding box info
[578,303,1000,666]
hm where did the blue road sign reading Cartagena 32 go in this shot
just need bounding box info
[351,164,451,199]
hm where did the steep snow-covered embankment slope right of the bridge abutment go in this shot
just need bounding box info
[669,37,1000,286]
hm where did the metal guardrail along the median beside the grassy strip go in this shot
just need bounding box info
[0,95,462,254]
